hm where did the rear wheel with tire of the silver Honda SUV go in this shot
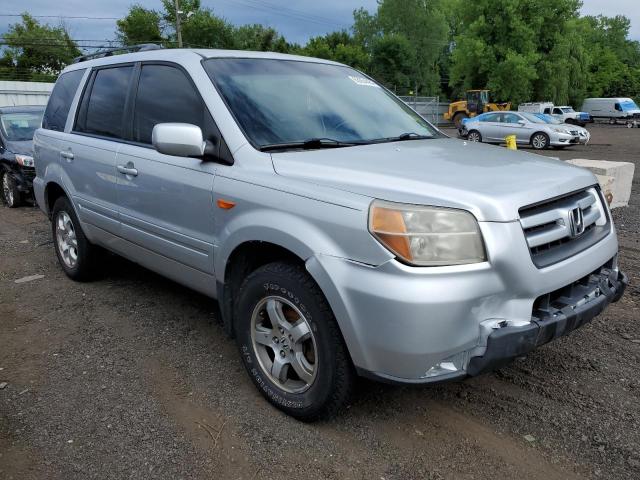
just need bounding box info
[51,197,98,281]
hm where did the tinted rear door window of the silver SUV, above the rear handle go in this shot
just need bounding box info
[76,65,133,138]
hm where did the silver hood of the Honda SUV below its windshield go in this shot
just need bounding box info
[272,138,596,222]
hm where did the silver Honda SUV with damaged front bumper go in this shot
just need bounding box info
[34,50,626,420]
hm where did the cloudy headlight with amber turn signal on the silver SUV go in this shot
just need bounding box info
[369,200,486,266]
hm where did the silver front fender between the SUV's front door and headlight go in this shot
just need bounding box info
[214,176,393,281]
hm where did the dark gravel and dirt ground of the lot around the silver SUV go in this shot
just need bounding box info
[0,127,640,480]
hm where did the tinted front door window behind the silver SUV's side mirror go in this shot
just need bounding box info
[133,64,208,144]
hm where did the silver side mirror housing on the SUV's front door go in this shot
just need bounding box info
[151,123,206,157]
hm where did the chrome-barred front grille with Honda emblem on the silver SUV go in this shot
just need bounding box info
[520,187,610,268]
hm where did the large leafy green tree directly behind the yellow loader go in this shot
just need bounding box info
[449,0,588,103]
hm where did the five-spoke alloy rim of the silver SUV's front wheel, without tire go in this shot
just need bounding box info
[251,296,318,393]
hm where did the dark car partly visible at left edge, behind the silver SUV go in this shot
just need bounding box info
[0,106,44,208]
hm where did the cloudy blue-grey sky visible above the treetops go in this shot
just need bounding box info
[0,0,640,49]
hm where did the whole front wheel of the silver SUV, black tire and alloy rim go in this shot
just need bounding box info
[234,262,355,421]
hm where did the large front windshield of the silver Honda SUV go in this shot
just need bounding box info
[204,58,440,148]
